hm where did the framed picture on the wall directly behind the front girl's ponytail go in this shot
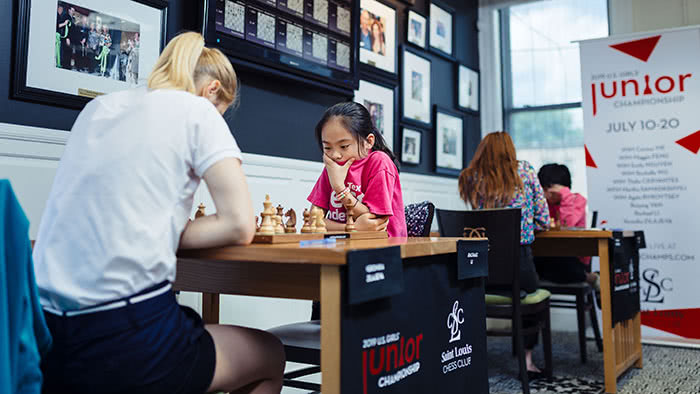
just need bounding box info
[355,80,397,151]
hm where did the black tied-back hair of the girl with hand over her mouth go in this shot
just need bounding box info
[316,101,400,171]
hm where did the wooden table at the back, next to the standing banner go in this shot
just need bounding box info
[532,230,642,393]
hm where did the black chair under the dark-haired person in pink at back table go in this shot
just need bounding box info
[540,211,603,364]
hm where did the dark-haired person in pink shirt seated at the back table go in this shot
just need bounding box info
[535,164,598,286]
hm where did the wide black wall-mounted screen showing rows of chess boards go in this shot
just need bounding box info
[202,0,359,96]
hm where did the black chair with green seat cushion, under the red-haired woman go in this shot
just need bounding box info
[435,208,552,394]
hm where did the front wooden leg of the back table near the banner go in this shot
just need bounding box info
[598,239,617,394]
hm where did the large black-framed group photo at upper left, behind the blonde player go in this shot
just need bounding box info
[12,0,168,109]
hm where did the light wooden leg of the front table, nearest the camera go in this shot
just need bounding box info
[321,265,341,394]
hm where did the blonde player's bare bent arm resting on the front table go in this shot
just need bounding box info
[180,158,255,249]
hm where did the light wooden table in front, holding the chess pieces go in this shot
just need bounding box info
[174,238,484,394]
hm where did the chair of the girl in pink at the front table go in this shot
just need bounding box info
[268,201,435,392]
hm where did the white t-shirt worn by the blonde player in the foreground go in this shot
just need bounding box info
[34,88,241,310]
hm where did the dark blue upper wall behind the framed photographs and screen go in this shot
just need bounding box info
[0,0,481,174]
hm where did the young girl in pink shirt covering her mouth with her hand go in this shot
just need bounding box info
[307,102,407,237]
